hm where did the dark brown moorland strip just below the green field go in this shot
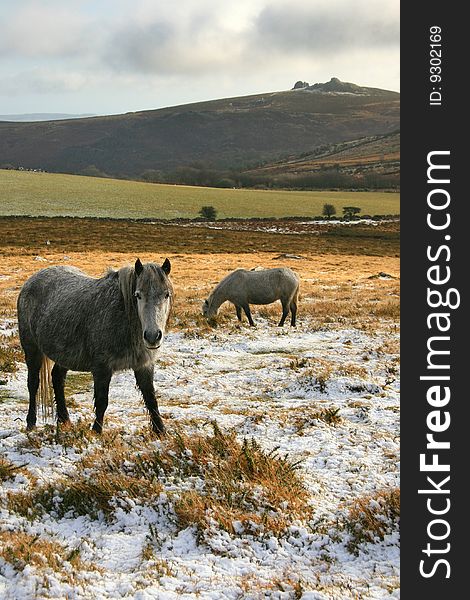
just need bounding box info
[0,217,399,255]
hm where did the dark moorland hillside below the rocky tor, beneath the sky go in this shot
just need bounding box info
[0,79,400,177]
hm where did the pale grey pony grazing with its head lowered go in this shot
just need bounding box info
[202,267,299,327]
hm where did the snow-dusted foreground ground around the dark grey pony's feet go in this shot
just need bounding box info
[0,320,399,600]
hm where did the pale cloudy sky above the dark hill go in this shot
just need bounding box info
[0,0,399,115]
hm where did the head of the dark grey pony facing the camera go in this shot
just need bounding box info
[134,258,173,350]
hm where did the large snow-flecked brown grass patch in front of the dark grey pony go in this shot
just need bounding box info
[7,423,310,534]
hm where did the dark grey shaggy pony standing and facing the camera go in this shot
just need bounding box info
[18,259,173,434]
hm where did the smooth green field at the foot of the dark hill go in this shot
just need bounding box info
[0,170,400,219]
